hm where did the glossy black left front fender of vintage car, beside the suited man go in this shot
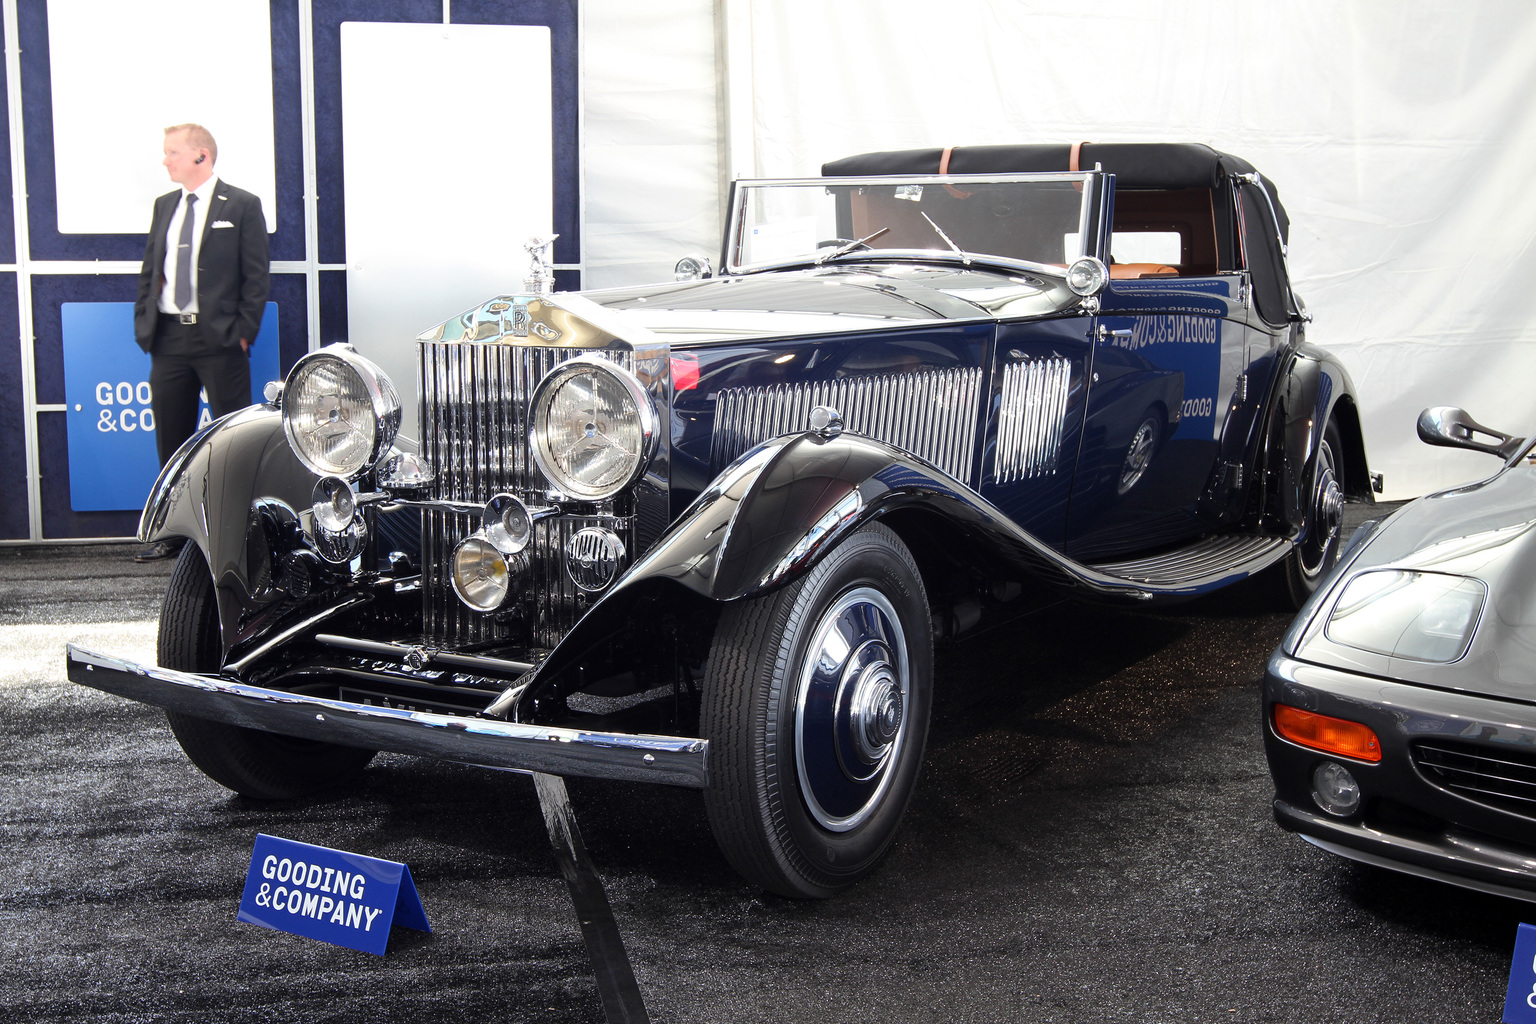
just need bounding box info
[138,405,315,651]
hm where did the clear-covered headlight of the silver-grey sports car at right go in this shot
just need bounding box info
[1327,570,1488,663]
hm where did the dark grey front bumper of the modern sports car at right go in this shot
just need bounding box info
[1264,652,1536,901]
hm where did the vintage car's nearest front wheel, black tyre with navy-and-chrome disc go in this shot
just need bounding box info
[700,524,934,898]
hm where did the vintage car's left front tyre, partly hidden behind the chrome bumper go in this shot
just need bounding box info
[160,543,373,800]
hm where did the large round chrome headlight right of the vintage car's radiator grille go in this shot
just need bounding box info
[528,356,657,500]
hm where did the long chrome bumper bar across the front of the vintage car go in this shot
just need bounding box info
[59,643,710,789]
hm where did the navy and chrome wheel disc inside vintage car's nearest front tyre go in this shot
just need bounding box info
[794,586,909,832]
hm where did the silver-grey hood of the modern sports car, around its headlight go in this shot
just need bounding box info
[1295,459,1536,703]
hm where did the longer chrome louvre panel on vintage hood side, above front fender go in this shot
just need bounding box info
[711,367,982,484]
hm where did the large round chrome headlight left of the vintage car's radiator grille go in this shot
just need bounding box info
[283,345,399,479]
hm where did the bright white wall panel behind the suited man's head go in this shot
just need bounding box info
[48,0,278,235]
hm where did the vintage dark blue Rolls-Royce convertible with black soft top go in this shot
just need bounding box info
[68,144,1372,897]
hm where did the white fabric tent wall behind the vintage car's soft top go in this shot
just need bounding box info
[584,0,1536,497]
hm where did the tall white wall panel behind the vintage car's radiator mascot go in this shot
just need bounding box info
[341,21,553,436]
